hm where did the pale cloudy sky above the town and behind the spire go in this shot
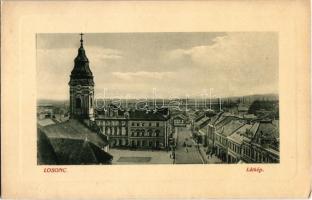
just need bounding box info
[36,32,278,100]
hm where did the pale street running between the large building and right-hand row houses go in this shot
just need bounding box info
[175,127,204,164]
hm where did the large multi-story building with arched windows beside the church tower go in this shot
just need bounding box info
[95,105,171,149]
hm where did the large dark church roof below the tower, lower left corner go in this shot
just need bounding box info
[38,119,112,164]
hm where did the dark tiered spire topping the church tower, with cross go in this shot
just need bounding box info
[69,35,94,85]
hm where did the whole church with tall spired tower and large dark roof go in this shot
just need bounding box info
[37,34,113,165]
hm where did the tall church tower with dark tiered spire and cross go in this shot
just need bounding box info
[69,33,94,120]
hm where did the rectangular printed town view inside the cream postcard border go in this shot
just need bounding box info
[36,32,280,166]
